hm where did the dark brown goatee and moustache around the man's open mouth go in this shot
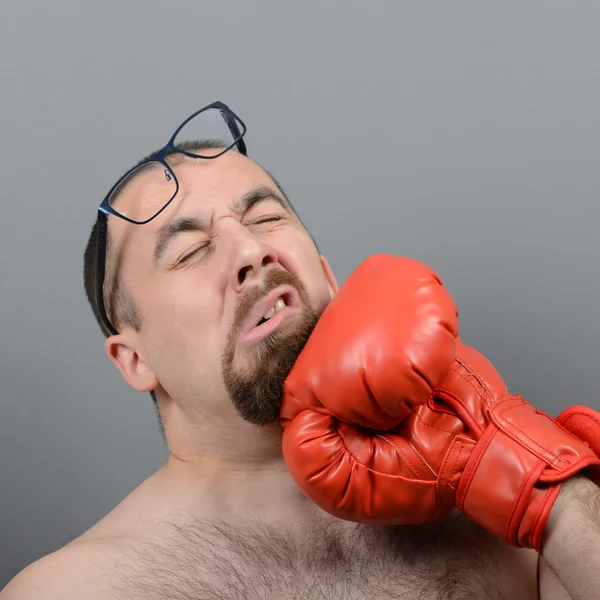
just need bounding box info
[221,271,319,425]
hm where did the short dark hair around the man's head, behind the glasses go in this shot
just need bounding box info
[83,140,318,408]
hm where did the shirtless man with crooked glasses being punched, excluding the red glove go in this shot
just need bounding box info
[0,104,600,600]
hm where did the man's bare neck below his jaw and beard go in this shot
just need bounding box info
[156,394,317,524]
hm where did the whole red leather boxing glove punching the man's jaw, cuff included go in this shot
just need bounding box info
[281,258,600,551]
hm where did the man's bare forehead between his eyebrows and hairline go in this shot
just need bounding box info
[109,150,276,245]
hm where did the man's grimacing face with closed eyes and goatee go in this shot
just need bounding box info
[110,151,336,424]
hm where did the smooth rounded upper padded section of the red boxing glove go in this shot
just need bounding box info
[281,254,458,436]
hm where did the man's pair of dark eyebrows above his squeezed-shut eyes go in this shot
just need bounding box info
[152,186,292,264]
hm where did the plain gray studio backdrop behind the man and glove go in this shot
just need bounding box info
[0,0,600,587]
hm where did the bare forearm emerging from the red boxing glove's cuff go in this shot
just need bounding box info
[542,476,600,600]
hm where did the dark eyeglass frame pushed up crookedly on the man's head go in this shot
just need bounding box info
[95,101,247,335]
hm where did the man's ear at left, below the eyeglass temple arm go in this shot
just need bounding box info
[104,330,159,392]
